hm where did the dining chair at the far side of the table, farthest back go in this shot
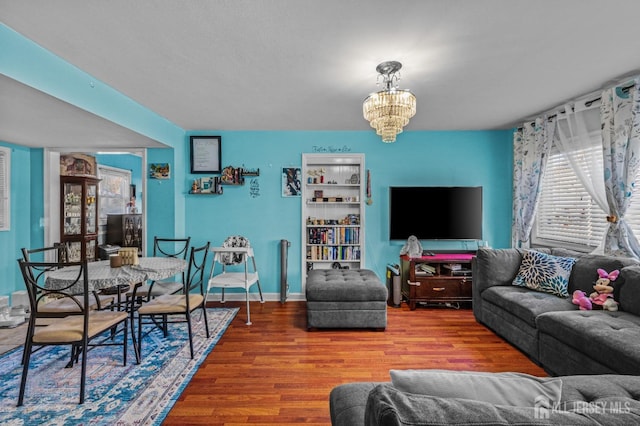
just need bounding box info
[127,236,191,300]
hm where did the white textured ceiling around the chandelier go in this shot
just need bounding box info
[0,0,640,147]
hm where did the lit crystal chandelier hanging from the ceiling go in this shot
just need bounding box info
[362,61,416,143]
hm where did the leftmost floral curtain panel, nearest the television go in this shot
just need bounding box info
[511,116,556,248]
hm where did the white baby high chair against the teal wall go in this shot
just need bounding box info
[205,235,264,325]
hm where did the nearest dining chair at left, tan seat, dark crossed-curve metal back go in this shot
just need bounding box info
[17,259,129,406]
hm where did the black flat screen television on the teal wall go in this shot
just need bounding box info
[389,186,482,240]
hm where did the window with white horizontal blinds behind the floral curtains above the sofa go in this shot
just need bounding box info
[532,145,640,251]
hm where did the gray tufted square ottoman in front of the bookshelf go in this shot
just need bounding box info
[306,269,387,329]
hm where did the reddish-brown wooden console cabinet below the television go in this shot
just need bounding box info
[400,253,474,310]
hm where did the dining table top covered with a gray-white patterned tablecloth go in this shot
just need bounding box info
[45,256,187,294]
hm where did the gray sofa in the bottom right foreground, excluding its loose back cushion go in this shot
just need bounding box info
[329,375,640,426]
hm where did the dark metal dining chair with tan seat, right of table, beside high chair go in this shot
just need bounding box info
[131,242,210,359]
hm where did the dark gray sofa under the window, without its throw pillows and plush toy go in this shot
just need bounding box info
[473,249,640,375]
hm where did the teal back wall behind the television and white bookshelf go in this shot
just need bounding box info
[182,131,512,293]
